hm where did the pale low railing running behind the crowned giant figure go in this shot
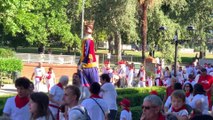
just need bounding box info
[16,53,141,65]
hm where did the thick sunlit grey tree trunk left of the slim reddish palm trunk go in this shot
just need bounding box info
[114,31,122,61]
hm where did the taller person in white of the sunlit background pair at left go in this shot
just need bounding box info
[31,62,45,92]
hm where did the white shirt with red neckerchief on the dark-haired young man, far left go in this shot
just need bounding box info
[3,96,31,120]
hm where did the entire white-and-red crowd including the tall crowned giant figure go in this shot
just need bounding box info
[2,18,213,120]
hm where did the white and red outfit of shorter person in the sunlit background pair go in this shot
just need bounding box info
[46,71,56,91]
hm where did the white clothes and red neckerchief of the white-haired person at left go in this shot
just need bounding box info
[49,83,64,119]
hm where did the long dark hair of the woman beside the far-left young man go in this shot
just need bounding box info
[30,92,49,119]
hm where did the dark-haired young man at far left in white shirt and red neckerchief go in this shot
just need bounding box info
[3,77,30,120]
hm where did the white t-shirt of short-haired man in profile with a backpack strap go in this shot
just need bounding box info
[68,105,87,120]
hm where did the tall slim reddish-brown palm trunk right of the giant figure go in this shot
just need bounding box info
[141,2,148,63]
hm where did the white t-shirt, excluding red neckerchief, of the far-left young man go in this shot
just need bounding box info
[3,96,31,120]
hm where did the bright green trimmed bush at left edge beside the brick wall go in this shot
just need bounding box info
[0,58,23,72]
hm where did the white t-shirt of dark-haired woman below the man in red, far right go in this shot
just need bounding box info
[189,94,209,114]
